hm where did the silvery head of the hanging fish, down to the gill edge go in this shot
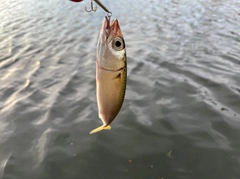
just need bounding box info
[97,17,126,71]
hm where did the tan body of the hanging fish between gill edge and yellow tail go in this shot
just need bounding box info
[96,64,126,126]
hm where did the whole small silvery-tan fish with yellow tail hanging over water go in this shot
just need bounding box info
[90,16,127,134]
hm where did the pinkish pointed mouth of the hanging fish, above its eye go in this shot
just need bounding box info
[101,17,120,42]
